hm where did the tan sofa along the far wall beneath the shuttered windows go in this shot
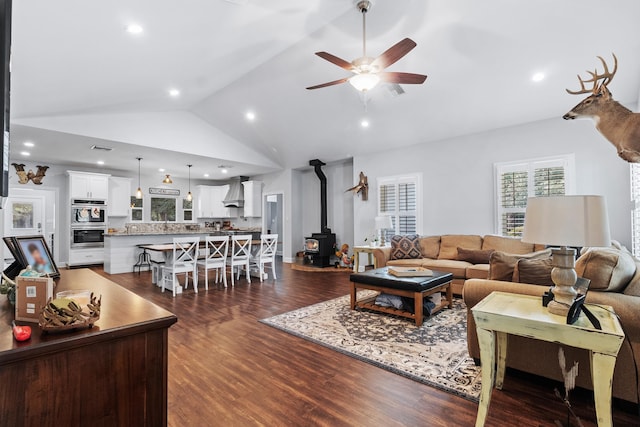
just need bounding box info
[374,234,544,295]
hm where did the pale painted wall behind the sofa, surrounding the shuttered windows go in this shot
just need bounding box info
[353,118,631,251]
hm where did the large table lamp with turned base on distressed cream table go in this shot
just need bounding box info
[522,196,611,316]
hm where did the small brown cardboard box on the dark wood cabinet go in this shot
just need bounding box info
[16,276,53,323]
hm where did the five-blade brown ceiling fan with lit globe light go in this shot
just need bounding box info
[307,0,427,92]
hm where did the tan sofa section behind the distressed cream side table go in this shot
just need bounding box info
[463,247,640,403]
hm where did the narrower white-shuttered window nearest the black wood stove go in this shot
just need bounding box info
[376,175,420,241]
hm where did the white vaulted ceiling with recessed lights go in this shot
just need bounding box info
[11,0,640,178]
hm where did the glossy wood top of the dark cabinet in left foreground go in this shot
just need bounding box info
[0,269,178,365]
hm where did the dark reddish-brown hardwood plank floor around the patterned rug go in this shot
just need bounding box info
[97,264,640,426]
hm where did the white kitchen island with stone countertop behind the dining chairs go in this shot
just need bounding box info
[104,229,260,274]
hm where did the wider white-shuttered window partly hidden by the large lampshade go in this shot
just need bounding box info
[495,155,574,237]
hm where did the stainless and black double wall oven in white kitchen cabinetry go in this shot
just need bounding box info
[71,199,107,248]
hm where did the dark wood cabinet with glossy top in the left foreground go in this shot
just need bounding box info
[0,269,177,426]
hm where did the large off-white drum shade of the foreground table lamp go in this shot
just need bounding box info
[522,196,611,247]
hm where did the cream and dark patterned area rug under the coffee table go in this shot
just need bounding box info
[261,291,481,402]
